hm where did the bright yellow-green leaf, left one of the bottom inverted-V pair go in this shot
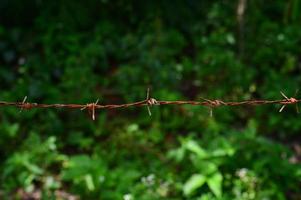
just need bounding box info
[183,174,206,196]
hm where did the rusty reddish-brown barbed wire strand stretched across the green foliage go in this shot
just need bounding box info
[0,89,301,120]
